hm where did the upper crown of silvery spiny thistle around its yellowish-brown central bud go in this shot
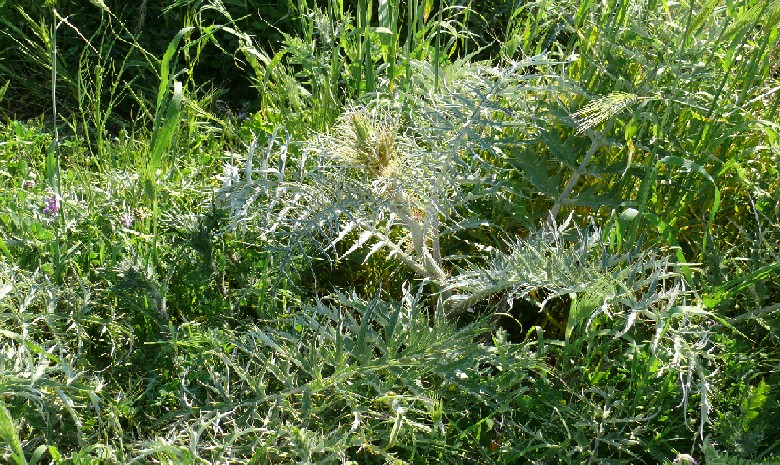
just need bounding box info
[217,54,568,296]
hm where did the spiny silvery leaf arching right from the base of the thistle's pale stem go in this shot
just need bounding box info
[447,219,676,318]
